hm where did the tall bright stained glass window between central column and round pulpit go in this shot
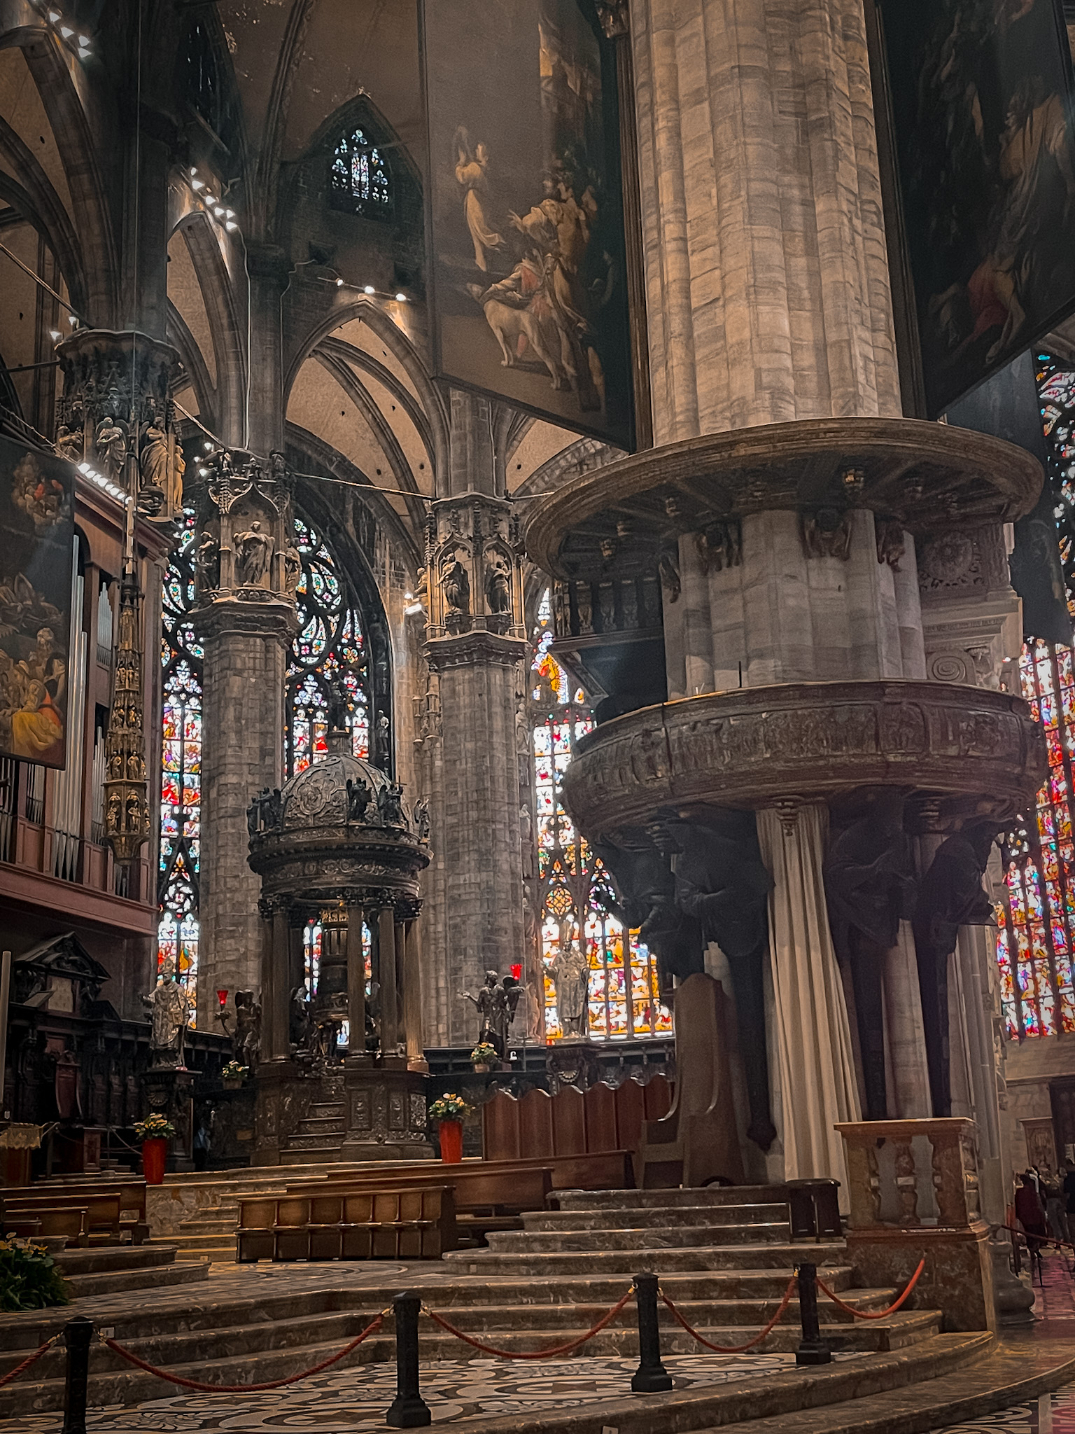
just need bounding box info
[530,592,672,1041]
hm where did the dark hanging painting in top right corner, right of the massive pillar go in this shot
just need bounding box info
[880,0,1075,417]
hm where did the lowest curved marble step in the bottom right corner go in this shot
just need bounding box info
[689,1341,1075,1434]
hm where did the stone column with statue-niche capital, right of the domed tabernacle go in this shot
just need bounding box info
[424,390,527,1045]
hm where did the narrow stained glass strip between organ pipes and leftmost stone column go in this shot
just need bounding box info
[156,513,202,1025]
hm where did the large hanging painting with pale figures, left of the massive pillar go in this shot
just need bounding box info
[423,0,634,449]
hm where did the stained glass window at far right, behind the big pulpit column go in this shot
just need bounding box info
[996,356,1075,1040]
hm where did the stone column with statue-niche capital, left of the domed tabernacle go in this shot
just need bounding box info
[191,449,298,1025]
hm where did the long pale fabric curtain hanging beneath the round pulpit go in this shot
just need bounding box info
[758,804,861,1209]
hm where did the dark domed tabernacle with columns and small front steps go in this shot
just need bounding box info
[248,726,431,1164]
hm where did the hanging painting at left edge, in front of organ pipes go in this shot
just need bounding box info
[0,437,75,767]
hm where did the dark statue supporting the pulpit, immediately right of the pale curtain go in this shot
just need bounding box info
[824,789,914,1120]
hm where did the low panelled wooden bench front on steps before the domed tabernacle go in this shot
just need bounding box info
[235,1184,456,1263]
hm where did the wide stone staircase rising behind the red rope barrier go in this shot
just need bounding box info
[0,1170,992,1430]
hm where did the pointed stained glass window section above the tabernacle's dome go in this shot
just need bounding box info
[285,518,370,777]
